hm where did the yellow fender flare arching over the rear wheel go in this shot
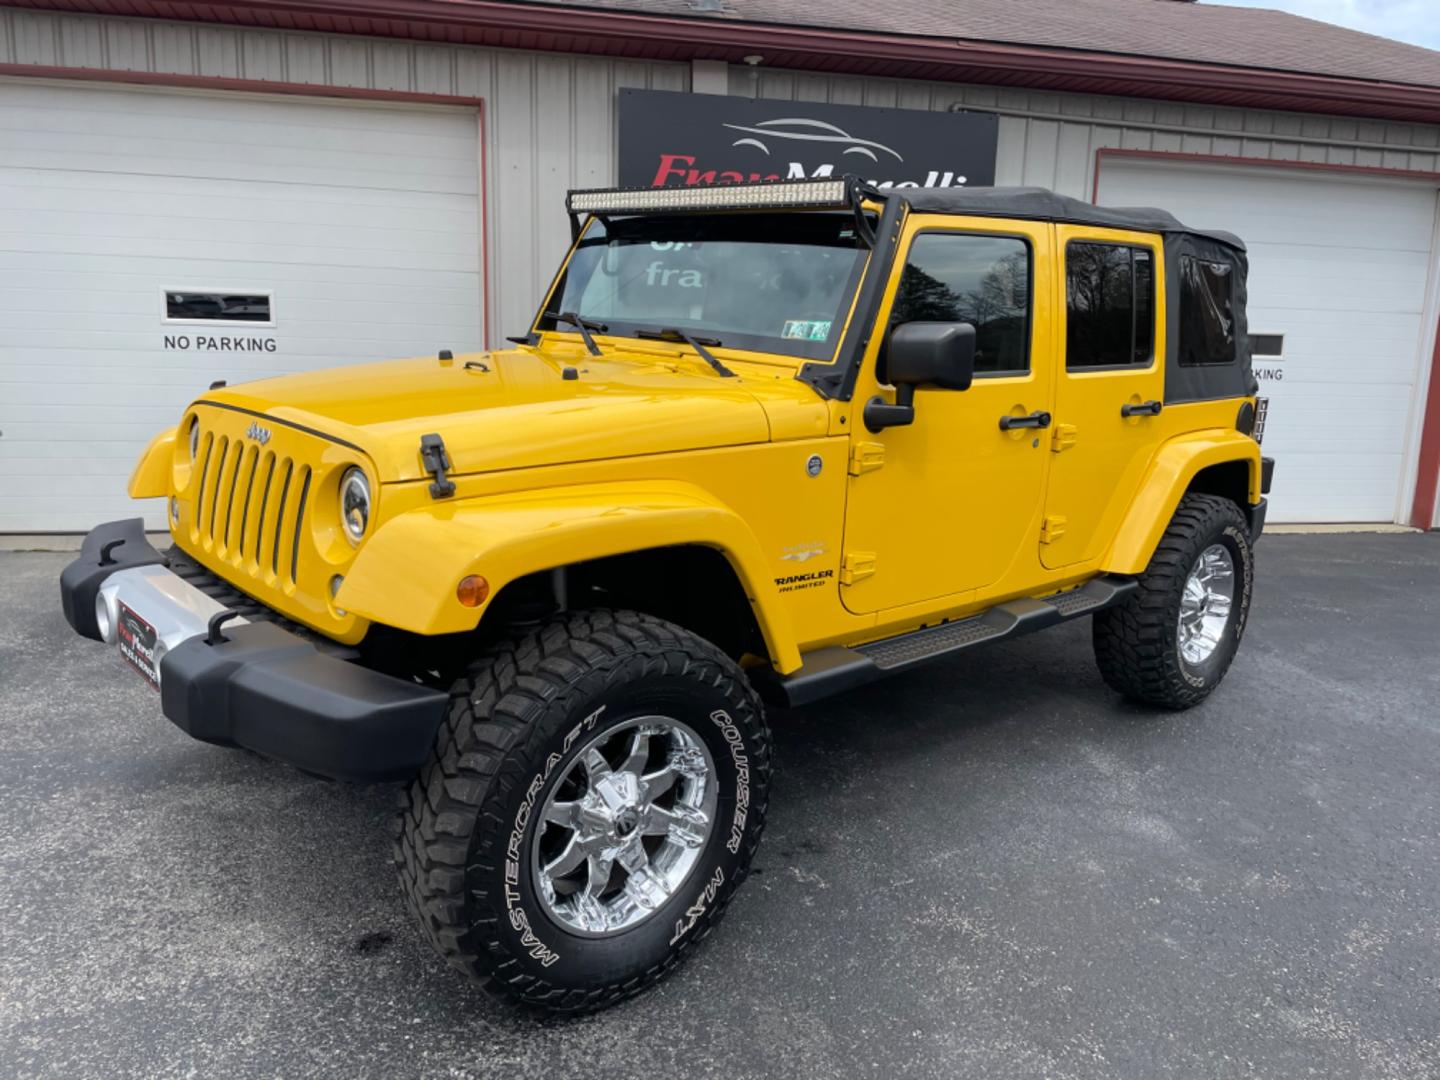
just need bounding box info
[1100,428,1260,573]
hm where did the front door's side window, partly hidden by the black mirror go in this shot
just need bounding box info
[890,232,1031,374]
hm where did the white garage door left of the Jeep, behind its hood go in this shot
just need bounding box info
[0,81,481,533]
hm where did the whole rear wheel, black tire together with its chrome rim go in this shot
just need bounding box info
[1093,495,1254,708]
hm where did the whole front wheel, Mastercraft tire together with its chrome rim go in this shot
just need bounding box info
[396,612,770,1012]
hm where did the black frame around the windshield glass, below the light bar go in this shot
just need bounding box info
[531,210,874,364]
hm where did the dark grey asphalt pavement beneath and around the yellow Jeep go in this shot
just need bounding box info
[0,534,1440,1080]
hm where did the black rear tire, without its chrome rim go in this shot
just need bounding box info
[1093,495,1254,708]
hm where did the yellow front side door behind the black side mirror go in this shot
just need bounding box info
[840,215,1058,613]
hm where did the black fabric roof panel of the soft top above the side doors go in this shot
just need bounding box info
[886,187,1246,251]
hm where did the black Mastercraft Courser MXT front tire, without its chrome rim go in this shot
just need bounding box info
[395,611,770,1014]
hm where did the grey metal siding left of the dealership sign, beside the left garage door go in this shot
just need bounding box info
[0,7,690,343]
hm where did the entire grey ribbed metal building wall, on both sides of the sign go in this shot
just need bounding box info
[0,7,1440,340]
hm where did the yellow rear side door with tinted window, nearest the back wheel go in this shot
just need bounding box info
[1040,225,1165,569]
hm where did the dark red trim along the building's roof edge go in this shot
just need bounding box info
[7,0,1440,122]
